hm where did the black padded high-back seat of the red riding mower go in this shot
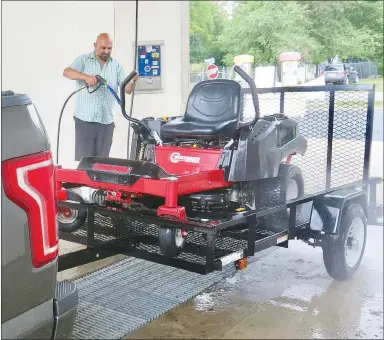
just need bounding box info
[161,79,242,139]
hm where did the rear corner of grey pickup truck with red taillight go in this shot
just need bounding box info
[1,91,78,339]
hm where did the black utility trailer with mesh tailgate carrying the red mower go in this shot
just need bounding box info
[56,75,382,280]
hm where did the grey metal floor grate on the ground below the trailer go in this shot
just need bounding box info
[72,258,234,339]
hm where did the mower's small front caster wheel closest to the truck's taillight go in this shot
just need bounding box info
[57,190,87,233]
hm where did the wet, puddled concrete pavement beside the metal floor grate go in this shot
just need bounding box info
[127,226,383,339]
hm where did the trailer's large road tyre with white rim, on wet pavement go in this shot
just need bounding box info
[323,204,367,281]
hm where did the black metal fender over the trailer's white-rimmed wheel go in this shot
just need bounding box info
[310,188,368,234]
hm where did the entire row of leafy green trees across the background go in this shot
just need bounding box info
[190,0,384,72]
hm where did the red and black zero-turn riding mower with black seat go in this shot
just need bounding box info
[56,66,307,257]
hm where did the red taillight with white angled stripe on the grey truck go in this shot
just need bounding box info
[2,152,59,268]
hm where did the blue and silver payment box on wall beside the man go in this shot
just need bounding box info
[135,41,164,93]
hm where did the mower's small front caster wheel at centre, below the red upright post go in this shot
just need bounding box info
[159,227,185,257]
